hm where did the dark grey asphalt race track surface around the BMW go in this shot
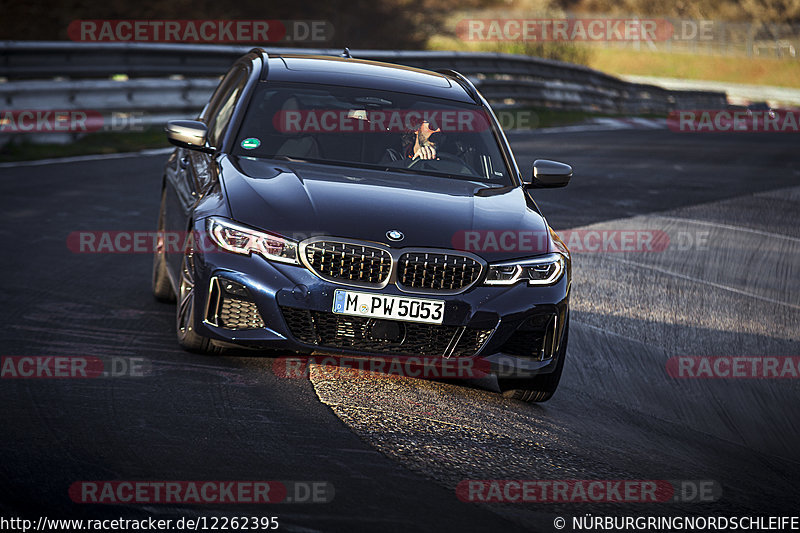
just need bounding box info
[0,130,800,531]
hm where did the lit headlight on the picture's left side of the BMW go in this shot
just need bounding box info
[206,217,298,265]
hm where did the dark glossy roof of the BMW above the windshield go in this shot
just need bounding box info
[262,54,476,104]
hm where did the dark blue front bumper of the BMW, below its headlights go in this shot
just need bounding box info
[188,233,570,377]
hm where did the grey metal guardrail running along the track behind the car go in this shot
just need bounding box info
[0,41,727,144]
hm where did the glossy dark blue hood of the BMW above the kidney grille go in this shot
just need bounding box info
[221,157,552,261]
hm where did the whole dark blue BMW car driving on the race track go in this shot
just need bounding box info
[153,49,572,401]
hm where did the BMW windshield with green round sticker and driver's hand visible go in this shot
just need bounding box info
[233,82,511,185]
